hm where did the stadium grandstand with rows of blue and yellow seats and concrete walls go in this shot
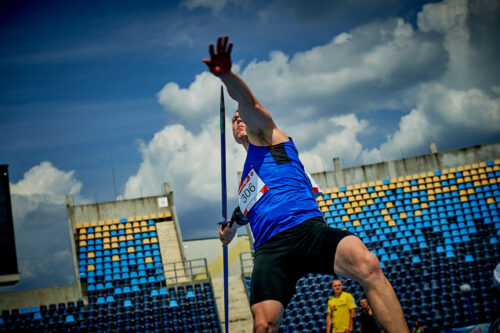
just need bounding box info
[0,142,500,332]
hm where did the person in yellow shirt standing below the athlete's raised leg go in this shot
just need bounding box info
[326,279,357,333]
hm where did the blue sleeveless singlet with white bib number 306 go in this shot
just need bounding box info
[239,138,323,247]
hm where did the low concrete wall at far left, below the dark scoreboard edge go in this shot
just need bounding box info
[0,284,82,310]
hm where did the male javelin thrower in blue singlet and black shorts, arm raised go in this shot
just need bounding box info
[203,36,408,333]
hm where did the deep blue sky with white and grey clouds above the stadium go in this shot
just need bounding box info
[0,0,500,292]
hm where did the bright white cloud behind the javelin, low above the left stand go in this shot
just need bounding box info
[124,117,244,209]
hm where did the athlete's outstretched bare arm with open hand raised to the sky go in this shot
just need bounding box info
[202,36,288,145]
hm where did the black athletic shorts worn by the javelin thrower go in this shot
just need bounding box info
[250,217,353,308]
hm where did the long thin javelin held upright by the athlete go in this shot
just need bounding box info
[220,86,229,333]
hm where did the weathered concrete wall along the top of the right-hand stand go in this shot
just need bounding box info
[312,142,500,190]
